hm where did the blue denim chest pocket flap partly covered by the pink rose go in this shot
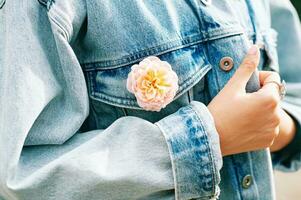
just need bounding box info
[86,43,211,109]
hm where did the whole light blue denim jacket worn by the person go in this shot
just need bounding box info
[0,0,301,200]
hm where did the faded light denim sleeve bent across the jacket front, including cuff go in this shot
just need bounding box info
[0,0,222,200]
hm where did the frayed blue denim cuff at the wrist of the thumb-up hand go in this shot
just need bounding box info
[156,101,222,199]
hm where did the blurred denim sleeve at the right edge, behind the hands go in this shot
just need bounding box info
[271,0,301,171]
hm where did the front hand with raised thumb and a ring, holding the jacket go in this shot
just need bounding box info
[208,45,281,156]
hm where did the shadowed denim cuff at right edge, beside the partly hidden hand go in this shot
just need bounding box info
[272,102,301,171]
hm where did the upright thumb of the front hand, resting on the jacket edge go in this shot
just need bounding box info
[227,45,260,90]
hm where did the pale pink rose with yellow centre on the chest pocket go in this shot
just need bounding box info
[127,56,179,111]
